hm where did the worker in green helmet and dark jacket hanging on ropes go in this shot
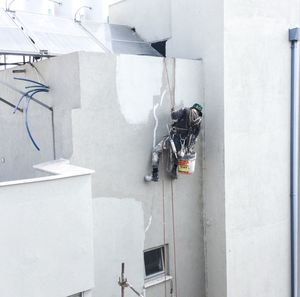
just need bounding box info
[145,103,202,182]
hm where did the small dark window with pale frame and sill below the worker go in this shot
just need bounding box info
[144,246,166,278]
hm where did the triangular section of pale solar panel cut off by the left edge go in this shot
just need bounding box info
[0,9,39,55]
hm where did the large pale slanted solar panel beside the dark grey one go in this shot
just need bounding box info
[16,12,104,55]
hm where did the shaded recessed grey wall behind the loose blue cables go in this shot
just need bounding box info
[0,69,54,181]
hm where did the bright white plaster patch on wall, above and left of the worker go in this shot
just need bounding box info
[116,55,163,124]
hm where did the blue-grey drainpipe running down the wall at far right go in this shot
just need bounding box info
[289,28,300,297]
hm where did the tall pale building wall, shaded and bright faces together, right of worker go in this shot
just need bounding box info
[111,0,299,297]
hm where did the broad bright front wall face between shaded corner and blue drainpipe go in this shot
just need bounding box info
[224,0,299,297]
